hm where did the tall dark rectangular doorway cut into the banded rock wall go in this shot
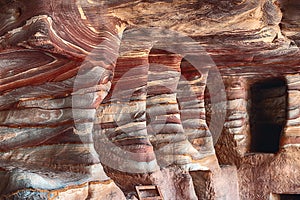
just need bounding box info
[250,78,287,153]
